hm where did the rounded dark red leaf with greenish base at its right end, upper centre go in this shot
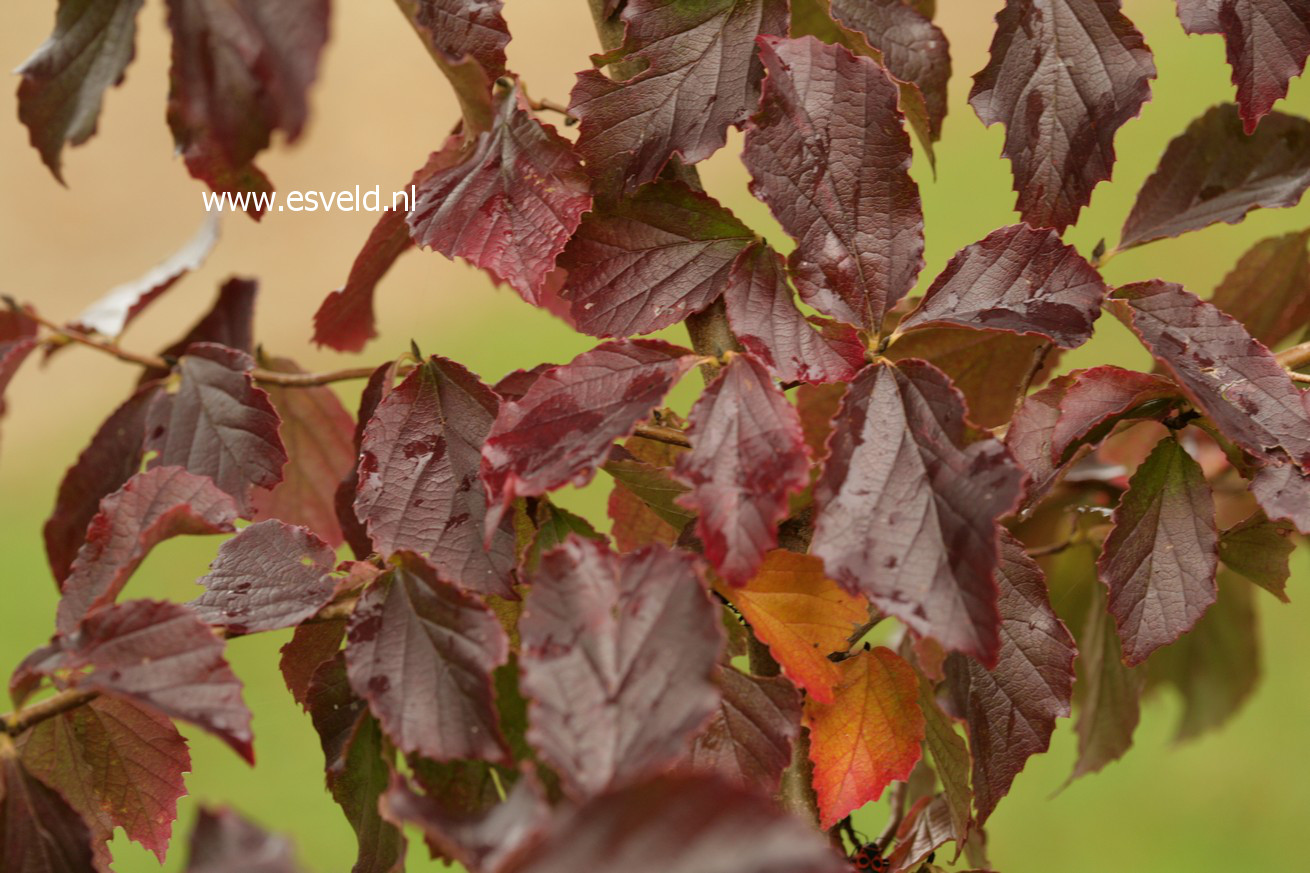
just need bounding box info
[559,181,755,337]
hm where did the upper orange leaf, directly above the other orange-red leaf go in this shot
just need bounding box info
[717,549,869,703]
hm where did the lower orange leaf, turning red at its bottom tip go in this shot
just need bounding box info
[804,648,924,830]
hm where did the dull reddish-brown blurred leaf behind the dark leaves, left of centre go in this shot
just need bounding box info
[253,358,356,548]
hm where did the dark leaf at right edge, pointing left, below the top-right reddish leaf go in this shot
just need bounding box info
[1119,104,1310,249]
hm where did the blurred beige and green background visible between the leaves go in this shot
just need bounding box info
[0,0,1310,873]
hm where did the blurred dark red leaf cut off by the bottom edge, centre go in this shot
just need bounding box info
[498,775,850,873]
